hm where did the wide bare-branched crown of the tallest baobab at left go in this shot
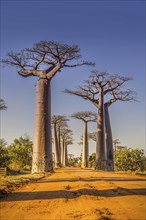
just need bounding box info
[2,41,93,79]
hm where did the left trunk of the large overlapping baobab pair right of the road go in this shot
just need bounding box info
[95,88,106,170]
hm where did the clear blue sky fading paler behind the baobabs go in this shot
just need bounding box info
[1,0,146,156]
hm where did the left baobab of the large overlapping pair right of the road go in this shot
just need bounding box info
[64,71,131,170]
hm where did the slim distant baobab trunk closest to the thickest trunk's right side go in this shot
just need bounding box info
[54,124,60,167]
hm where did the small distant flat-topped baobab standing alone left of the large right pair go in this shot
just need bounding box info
[71,111,97,168]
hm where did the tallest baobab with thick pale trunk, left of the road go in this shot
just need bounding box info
[2,41,93,173]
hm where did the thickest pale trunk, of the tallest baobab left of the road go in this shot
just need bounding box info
[32,79,53,173]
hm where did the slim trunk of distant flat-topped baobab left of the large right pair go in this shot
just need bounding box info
[82,122,88,168]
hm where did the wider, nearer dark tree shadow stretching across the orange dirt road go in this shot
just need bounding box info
[1,187,146,202]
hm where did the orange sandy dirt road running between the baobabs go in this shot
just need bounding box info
[0,168,146,220]
